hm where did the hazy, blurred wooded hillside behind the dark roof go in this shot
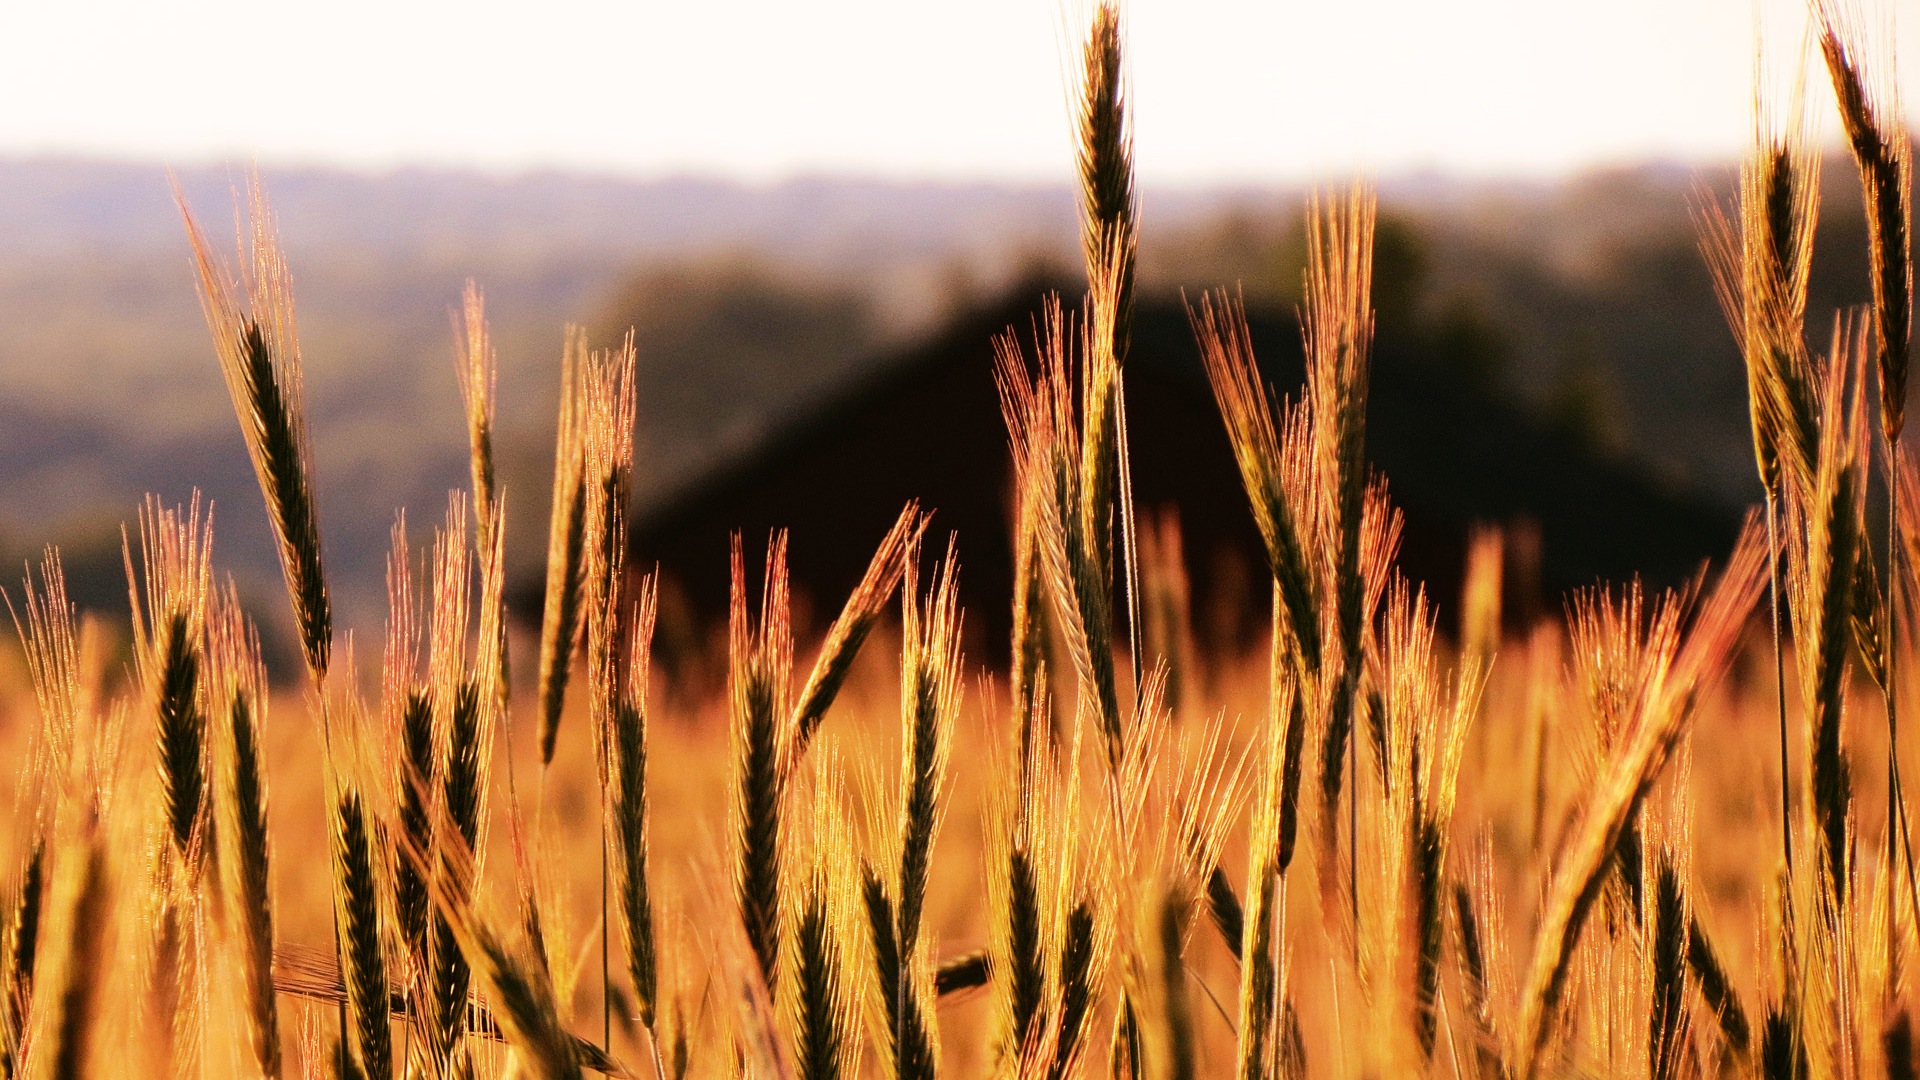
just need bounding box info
[0,160,1889,653]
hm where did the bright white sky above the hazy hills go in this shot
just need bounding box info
[0,0,1920,183]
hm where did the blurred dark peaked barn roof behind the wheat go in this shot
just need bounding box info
[630,278,1738,655]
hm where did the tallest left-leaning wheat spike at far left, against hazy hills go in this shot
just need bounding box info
[175,173,334,684]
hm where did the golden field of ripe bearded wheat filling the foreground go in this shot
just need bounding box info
[0,0,1920,1080]
